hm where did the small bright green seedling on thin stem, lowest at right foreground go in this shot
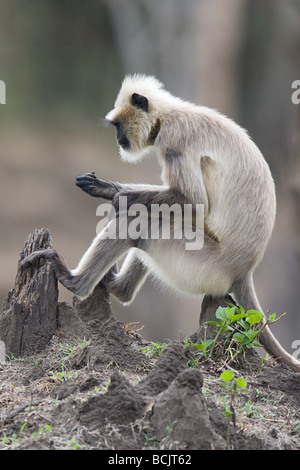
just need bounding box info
[219,370,247,447]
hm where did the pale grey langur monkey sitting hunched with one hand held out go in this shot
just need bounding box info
[21,75,300,371]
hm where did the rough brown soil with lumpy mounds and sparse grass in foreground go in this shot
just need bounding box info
[0,293,300,450]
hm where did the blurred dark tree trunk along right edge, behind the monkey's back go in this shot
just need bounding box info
[240,0,300,342]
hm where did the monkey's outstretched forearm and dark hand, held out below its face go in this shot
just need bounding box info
[76,173,167,199]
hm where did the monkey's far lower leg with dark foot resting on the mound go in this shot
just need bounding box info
[106,250,149,303]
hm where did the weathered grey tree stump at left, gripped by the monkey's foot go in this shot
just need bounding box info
[0,229,58,357]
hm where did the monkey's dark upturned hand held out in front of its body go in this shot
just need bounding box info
[76,172,121,199]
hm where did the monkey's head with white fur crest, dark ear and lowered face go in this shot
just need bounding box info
[105,75,172,162]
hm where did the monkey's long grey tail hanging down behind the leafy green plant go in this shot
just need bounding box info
[232,273,300,372]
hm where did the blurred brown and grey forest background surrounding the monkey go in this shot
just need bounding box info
[0,0,300,352]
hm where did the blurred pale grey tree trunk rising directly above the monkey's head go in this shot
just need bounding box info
[107,0,247,116]
